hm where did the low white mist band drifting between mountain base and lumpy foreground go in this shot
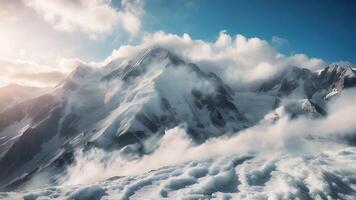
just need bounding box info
[65,90,356,185]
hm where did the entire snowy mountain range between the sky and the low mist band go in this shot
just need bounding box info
[0,47,356,190]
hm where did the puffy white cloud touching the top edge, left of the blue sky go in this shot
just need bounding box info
[26,0,143,37]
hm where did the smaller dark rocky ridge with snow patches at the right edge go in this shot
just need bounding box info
[259,65,356,104]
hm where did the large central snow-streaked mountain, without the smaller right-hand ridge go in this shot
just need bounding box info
[0,47,251,191]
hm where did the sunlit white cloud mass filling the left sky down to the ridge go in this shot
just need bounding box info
[0,0,144,87]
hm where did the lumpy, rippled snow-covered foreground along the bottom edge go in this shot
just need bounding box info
[0,148,356,200]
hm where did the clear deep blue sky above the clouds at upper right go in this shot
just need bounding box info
[143,0,356,63]
